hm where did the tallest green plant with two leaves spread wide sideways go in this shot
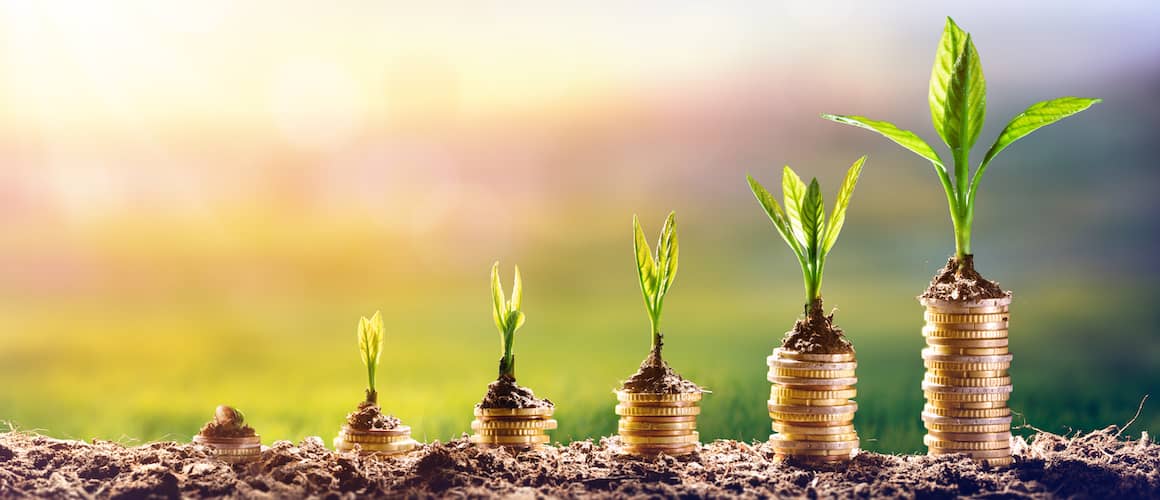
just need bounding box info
[821,17,1101,274]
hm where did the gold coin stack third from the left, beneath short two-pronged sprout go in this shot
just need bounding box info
[471,406,556,449]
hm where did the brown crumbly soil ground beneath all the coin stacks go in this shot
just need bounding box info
[0,427,1160,498]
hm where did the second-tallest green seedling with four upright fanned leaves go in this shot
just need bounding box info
[748,157,867,317]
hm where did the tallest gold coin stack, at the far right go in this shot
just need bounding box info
[920,297,1014,466]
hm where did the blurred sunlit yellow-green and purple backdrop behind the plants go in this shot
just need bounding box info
[0,0,1160,452]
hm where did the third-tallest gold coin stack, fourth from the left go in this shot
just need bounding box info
[616,391,701,457]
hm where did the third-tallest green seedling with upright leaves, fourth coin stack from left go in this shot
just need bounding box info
[632,212,677,356]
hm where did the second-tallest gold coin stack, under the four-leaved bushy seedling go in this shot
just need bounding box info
[767,348,860,466]
